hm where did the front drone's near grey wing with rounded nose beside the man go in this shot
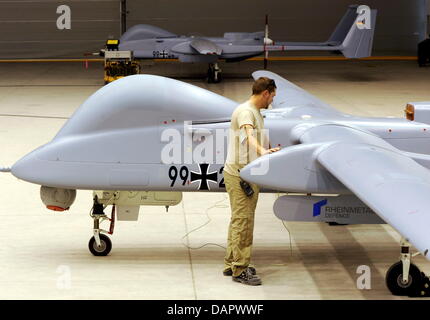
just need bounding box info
[241,124,430,259]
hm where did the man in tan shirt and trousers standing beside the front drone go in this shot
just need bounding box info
[223,77,279,285]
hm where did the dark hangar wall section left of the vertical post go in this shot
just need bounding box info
[0,0,120,58]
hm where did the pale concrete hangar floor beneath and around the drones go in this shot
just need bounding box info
[0,61,430,300]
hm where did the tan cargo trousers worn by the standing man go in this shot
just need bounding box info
[224,171,260,277]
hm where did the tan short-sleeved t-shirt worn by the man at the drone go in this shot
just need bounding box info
[224,100,268,176]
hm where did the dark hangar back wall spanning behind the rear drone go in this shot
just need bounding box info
[0,0,427,58]
